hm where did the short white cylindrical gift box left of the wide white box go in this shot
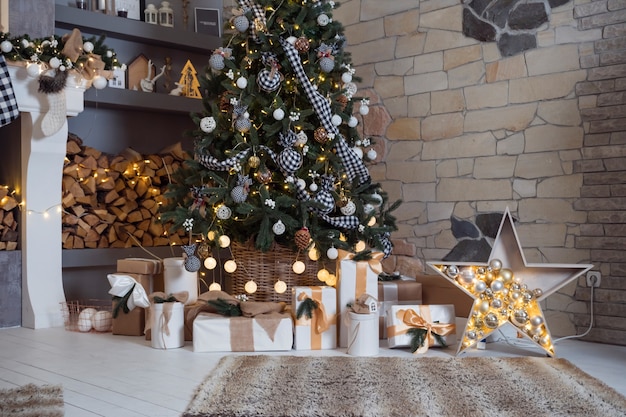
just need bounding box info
[150,302,185,349]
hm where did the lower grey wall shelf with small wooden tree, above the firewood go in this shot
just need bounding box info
[85,87,203,114]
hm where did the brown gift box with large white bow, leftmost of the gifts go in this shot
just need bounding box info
[107,274,150,336]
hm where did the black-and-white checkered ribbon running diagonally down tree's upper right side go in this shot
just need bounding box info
[280,38,370,184]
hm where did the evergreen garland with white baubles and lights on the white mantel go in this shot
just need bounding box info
[0,29,120,94]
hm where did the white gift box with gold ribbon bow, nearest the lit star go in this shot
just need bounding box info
[387,304,456,353]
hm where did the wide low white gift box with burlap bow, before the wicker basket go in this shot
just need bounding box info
[193,313,293,352]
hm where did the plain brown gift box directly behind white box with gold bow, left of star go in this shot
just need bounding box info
[378,278,422,339]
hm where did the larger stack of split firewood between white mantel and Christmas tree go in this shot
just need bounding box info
[62,134,188,249]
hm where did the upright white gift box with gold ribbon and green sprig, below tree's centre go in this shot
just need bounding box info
[291,286,337,350]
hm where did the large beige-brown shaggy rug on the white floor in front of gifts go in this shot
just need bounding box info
[183,356,626,417]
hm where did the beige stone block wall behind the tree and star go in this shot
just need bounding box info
[334,0,626,344]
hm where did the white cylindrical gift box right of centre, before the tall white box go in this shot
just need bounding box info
[345,311,379,356]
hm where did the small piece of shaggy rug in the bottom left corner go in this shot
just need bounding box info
[0,384,64,417]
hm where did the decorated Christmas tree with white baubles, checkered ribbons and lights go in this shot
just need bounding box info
[162,0,399,272]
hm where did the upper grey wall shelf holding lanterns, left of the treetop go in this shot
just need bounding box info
[55,4,222,55]
